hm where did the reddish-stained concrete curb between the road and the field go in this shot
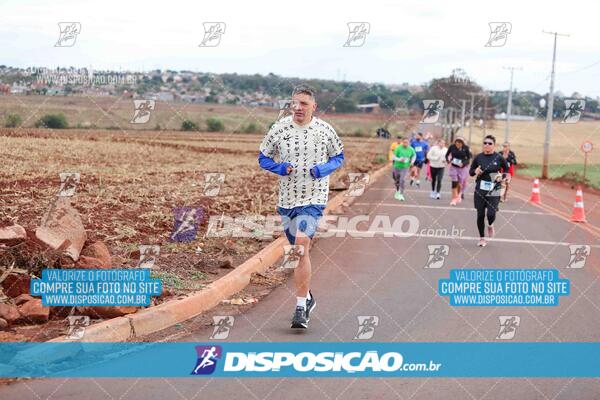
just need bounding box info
[50,164,391,342]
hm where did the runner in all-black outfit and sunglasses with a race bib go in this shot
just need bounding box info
[469,135,508,247]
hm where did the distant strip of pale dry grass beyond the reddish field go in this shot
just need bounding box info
[0,95,414,136]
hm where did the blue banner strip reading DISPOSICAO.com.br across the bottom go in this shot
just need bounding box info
[0,342,600,378]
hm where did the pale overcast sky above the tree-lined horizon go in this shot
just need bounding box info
[0,0,600,97]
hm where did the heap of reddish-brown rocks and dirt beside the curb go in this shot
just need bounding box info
[0,196,138,330]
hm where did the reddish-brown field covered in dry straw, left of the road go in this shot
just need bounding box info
[0,129,388,277]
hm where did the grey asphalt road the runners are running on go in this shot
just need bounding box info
[0,176,600,400]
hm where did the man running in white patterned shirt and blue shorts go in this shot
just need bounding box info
[258,85,344,328]
